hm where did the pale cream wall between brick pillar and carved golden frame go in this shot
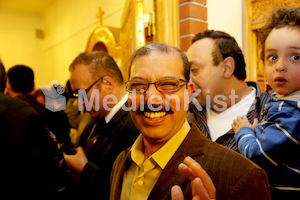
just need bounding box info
[207,0,243,49]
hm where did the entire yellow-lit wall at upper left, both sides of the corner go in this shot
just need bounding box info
[0,0,125,88]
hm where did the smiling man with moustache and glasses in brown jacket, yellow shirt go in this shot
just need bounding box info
[110,43,269,200]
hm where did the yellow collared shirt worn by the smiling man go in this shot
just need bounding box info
[121,120,191,200]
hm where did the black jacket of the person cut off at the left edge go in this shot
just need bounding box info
[0,92,60,199]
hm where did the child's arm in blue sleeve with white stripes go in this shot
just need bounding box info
[231,103,300,164]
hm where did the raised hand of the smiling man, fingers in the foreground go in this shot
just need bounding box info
[171,157,216,200]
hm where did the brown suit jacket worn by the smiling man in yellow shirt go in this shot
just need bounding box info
[110,125,270,200]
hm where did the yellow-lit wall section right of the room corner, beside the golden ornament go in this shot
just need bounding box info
[42,0,124,87]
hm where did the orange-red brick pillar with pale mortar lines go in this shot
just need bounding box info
[179,0,208,51]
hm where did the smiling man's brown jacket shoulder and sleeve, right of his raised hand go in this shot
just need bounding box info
[186,125,268,199]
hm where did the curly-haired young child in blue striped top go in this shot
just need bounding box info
[232,8,300,200]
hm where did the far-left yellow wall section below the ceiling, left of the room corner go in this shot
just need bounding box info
[0,9,43,86]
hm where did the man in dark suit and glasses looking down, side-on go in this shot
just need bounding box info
[64,52,138,199]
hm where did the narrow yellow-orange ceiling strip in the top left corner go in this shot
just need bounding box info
[0,0,56,14]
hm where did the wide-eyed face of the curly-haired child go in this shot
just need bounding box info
[264,27,300,95]
